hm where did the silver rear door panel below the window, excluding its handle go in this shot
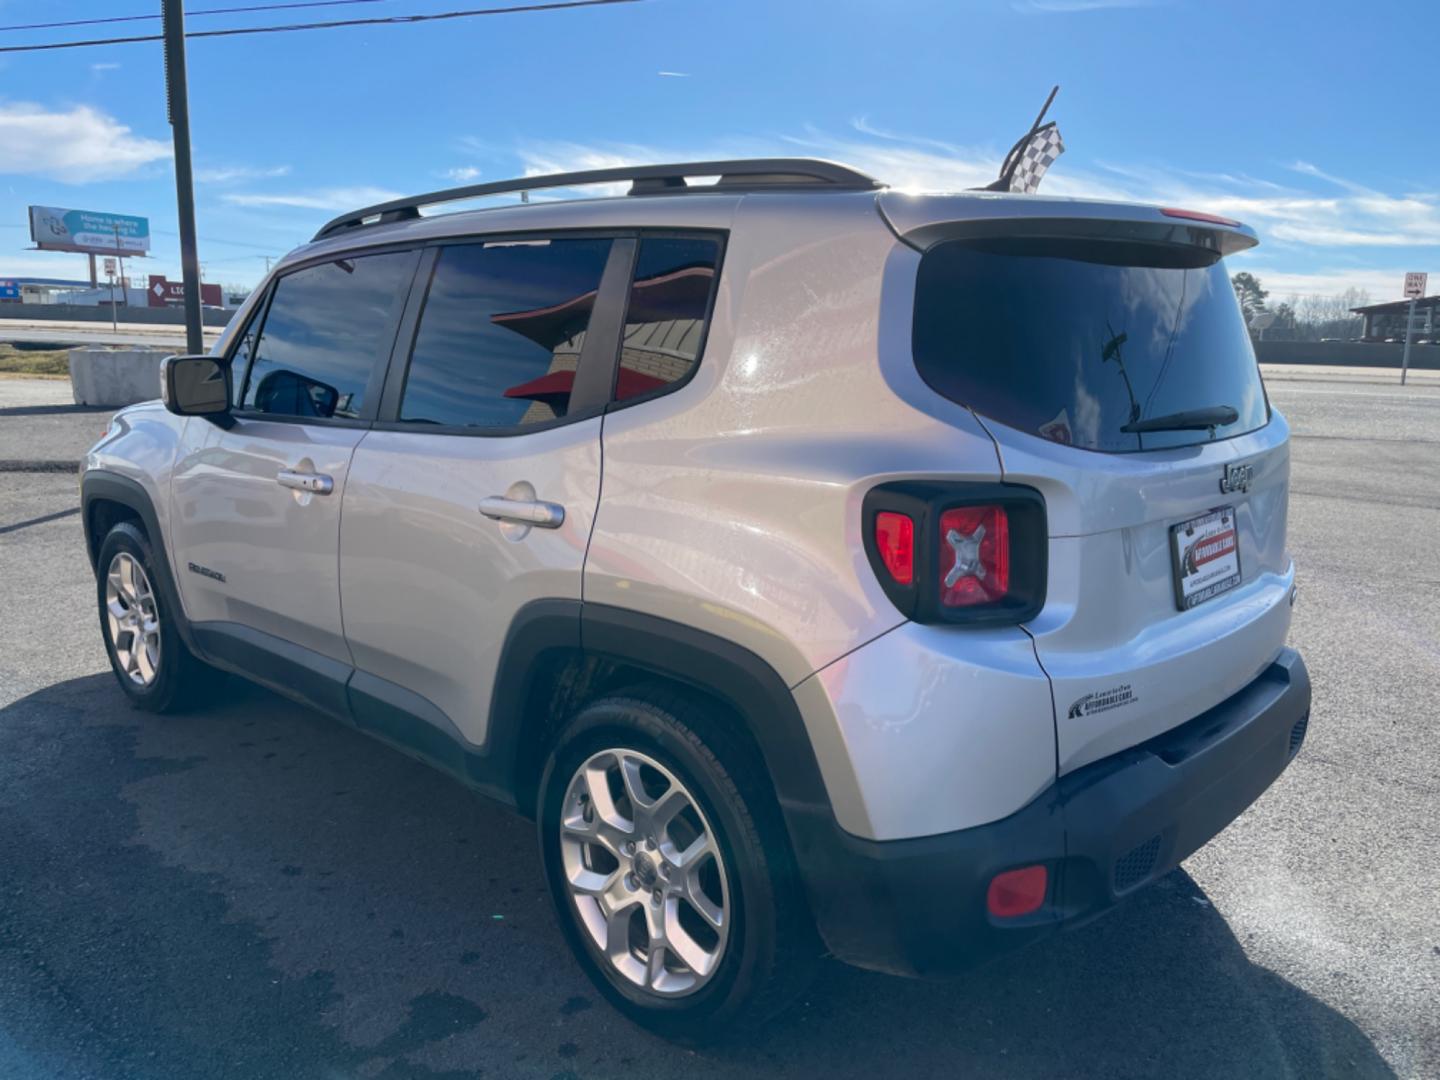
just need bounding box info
[340,416,600,744]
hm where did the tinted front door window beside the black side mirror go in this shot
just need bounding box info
[243,252,415,419]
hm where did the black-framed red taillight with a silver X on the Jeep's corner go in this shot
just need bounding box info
[863,481,1048,625]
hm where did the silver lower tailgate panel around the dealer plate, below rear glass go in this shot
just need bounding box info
[985,413,1295,773]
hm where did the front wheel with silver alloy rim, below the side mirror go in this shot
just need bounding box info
[95,521,216,713]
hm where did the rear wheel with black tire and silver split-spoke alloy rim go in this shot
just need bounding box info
[537,687,822,1044]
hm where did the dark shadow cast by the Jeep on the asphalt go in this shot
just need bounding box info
[0,672,1392,1080]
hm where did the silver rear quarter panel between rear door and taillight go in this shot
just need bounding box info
[585,196,998,685]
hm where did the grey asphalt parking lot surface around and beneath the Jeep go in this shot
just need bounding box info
[0,373,1440,1080]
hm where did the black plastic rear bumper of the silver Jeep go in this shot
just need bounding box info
[789,649,1310,975]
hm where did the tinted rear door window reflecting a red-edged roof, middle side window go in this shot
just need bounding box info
[400,239,611,428]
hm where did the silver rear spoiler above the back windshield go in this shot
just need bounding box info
[877,192,1260,256]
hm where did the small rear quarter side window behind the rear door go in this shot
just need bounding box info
[615,236,720,402]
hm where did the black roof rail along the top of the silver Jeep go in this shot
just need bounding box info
[315,157,881,240]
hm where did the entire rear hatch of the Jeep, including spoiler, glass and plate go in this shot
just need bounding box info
[881,194,1293,773]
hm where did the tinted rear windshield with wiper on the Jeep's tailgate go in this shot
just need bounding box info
[913,239,1269,454]
